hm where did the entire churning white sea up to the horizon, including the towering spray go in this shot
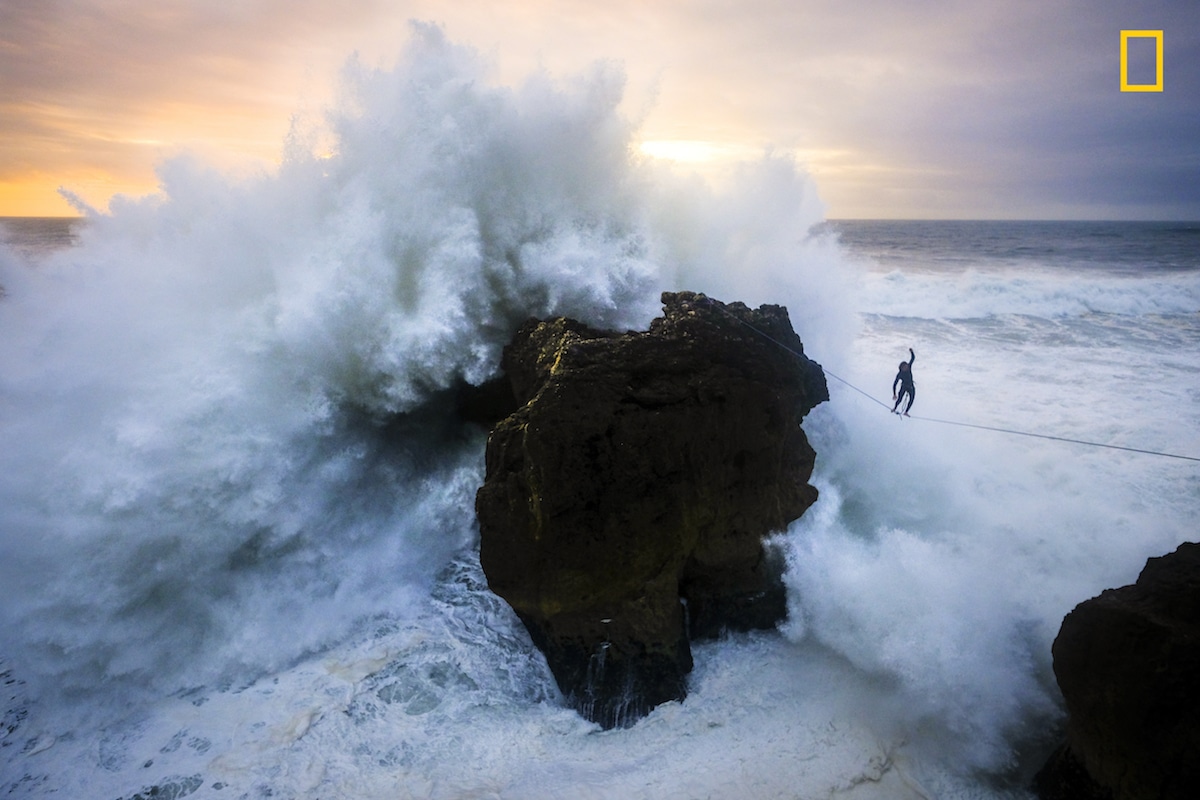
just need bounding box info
[0,28,1200,800]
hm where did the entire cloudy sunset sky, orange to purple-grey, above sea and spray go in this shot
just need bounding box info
[0,0,1200,219]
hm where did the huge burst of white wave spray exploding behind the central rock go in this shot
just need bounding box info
[0,25,852,724]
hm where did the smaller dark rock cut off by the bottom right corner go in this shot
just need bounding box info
[1037,543,1200,800]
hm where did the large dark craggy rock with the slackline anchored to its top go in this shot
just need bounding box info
[475,293,828,727]
